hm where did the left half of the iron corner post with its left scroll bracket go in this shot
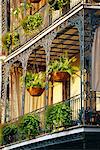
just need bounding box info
[68,10,85,124]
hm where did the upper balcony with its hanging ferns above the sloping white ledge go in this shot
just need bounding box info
[3,0,100,55]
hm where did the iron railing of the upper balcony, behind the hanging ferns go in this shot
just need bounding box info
[4,0,97,53]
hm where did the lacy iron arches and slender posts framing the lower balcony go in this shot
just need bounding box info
[2,5,96,123]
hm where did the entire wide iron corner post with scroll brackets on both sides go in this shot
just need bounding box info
[68,9,98,124]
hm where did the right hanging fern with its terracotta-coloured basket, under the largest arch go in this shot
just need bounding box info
[48,54,79,82]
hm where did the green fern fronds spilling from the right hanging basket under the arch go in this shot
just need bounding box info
[48,54,79,75]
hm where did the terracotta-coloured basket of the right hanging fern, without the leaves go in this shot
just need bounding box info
[51,71,69,82]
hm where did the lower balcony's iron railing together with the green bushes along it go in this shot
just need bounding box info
[0,95,100,145]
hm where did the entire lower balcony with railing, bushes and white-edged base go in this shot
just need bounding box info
[0,95,100,149]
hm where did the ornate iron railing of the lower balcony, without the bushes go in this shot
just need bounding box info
[1,95,100,145]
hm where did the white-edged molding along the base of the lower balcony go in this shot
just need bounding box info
[4,126,100,150]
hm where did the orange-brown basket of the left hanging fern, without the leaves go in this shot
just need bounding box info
[27,87,45,96]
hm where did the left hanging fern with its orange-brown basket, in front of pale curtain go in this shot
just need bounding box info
[25,72,45,96]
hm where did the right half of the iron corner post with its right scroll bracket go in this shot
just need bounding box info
[84,9,100,123]
